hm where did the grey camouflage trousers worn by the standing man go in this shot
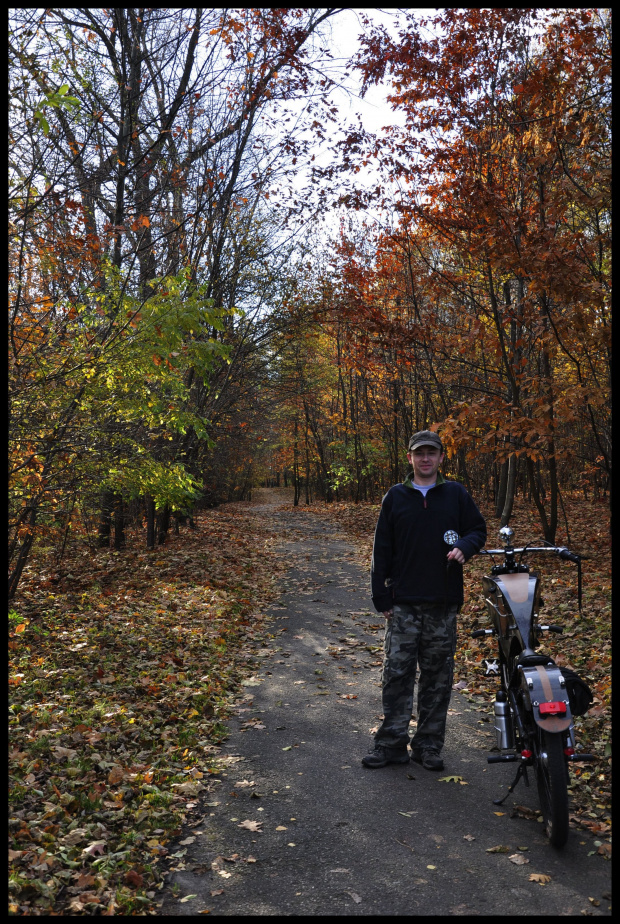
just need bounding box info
[375,603,458,751]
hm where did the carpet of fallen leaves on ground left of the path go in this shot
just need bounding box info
[9,504,287,914]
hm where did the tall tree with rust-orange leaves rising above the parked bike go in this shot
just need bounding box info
[342,10,610,539]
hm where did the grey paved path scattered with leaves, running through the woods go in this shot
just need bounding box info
[160,489,611,916]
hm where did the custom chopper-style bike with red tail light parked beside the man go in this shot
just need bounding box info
[471,526,596,847]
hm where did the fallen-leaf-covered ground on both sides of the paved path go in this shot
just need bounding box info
[9,499,611,915]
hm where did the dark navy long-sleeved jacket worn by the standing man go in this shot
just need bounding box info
[371,474,487,613]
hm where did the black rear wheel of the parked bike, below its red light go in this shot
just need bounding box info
[535,728,568,847]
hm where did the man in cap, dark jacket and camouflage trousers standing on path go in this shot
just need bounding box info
[362,430,486,770]
